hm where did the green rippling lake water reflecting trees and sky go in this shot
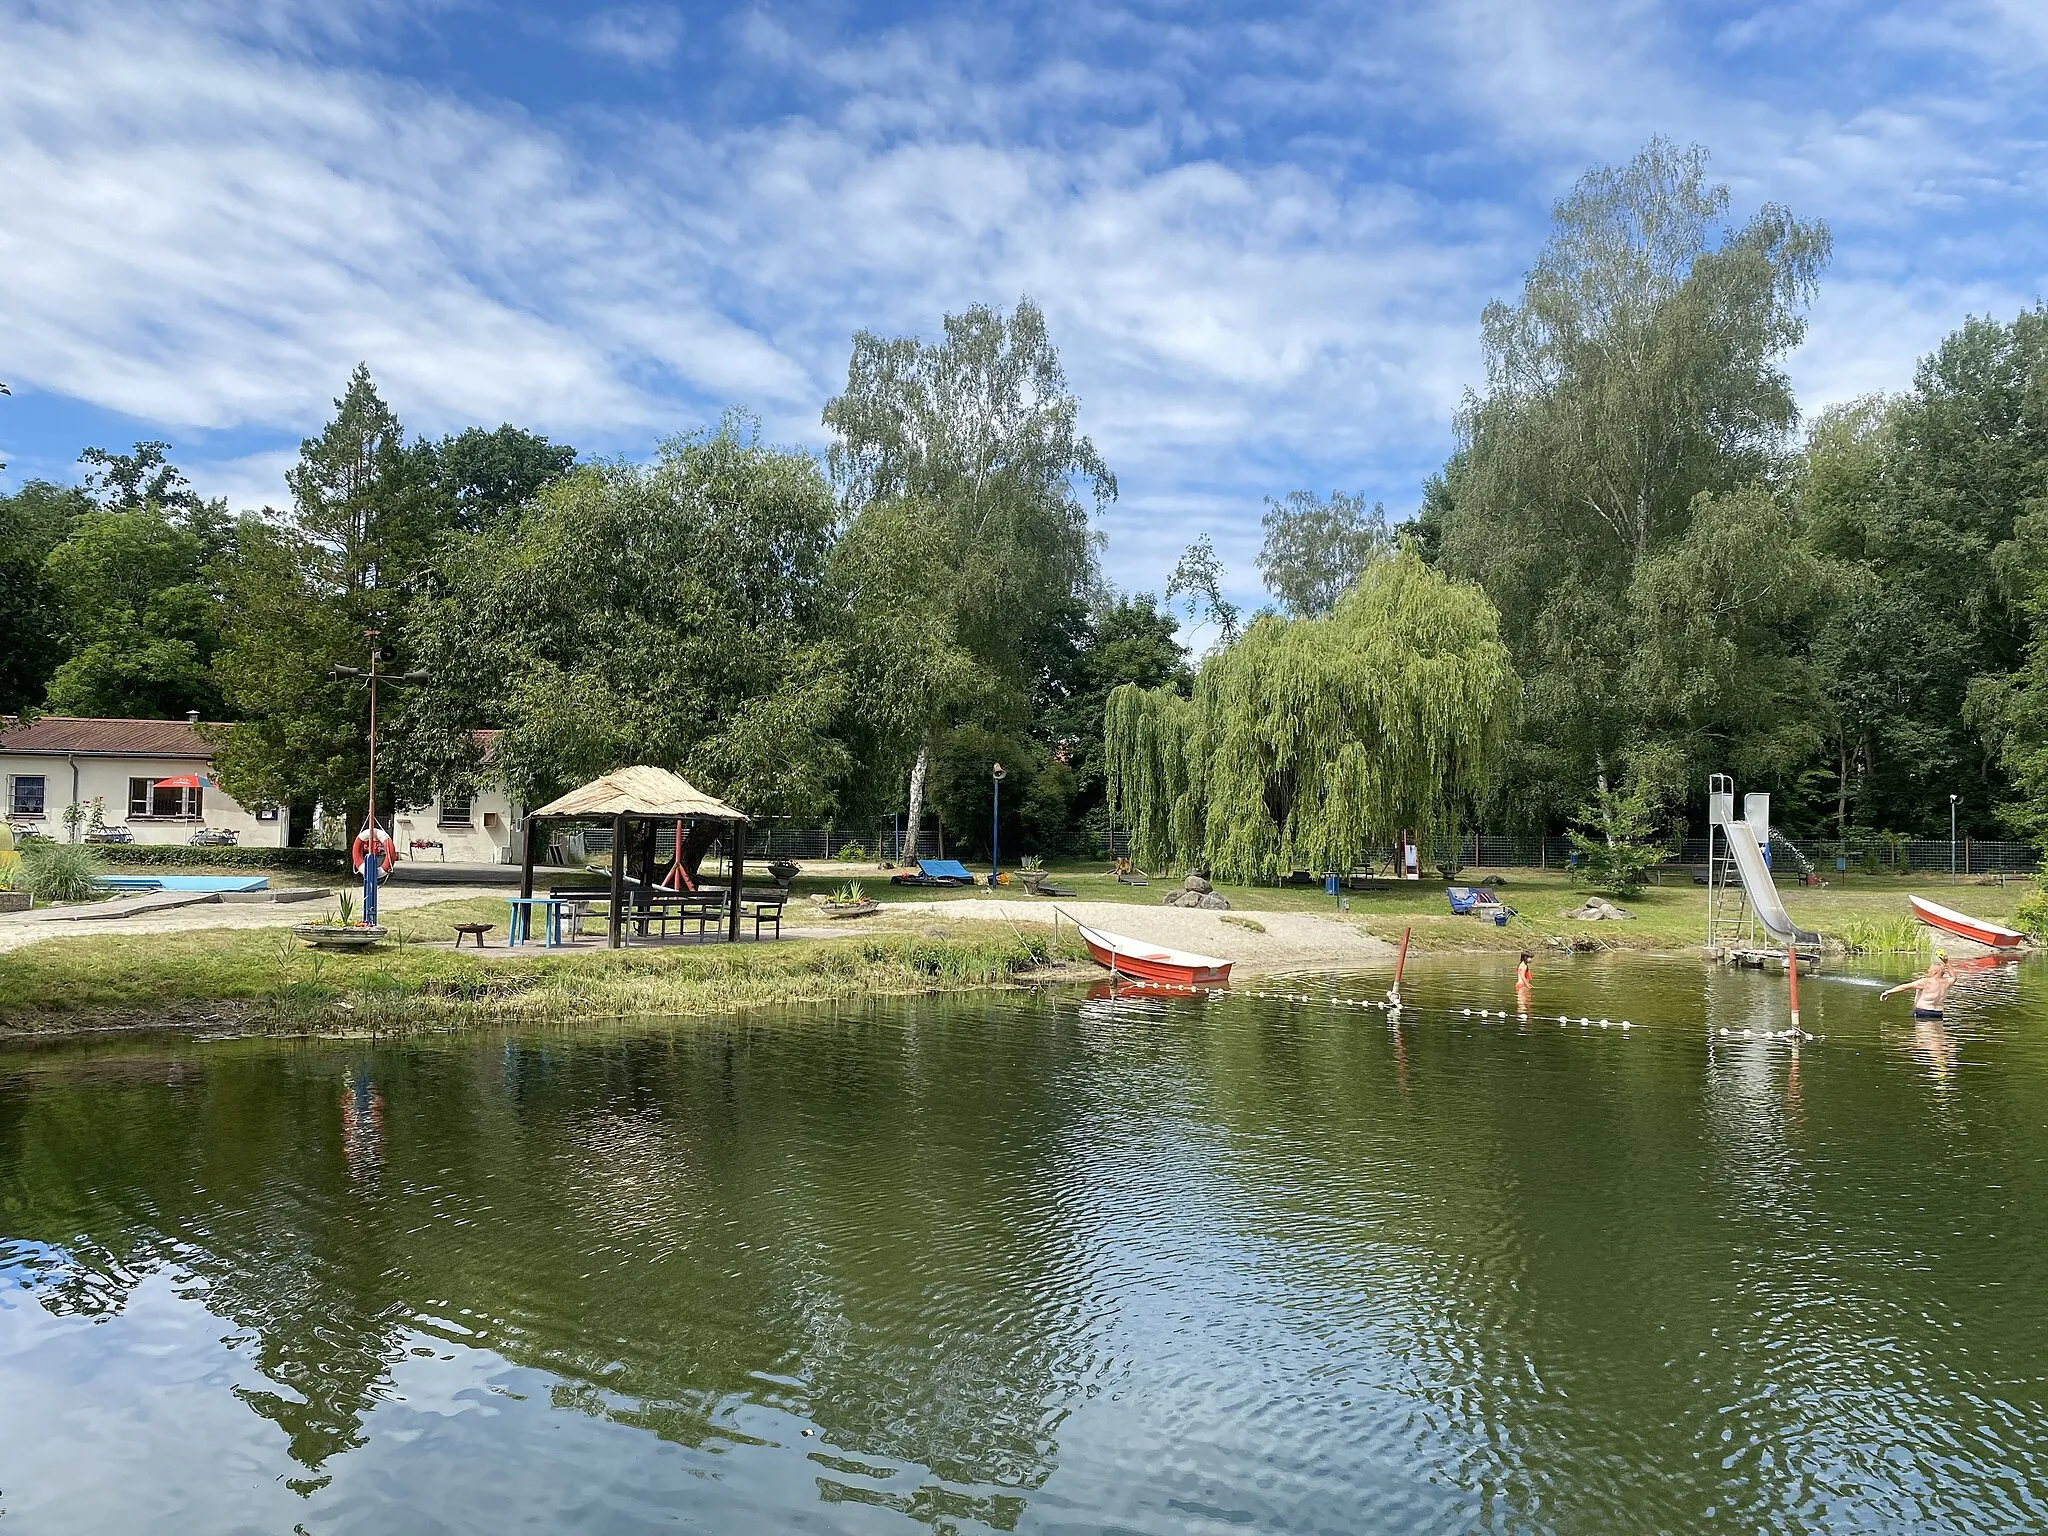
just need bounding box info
[0,958,2048,1534]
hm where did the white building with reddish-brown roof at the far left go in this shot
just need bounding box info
[0,715,287,848]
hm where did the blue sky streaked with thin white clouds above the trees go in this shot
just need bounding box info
[0,0,2048,614]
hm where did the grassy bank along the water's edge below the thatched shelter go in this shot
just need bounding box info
[0,901,1081,1034]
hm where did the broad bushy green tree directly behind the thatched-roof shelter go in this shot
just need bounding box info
[391,418,848,817]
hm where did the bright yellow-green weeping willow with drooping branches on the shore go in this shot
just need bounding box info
[1104,551,1520,881]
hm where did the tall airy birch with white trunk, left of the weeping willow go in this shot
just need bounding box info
[825,299,1116,860]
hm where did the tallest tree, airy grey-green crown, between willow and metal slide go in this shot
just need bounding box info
[1430,139,1829,821]
